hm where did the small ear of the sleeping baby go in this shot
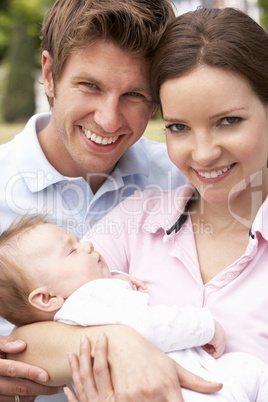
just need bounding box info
[28,287,64,312]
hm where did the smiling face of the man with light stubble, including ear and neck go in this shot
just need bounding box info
[40,41,154,178]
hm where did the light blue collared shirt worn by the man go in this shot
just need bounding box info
[0,113,185,401]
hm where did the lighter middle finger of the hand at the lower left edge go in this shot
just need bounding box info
[0,359,49,382]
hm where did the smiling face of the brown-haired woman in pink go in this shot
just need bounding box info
[160,65,268,204]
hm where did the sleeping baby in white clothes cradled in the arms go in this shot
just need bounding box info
[0,216,268,402]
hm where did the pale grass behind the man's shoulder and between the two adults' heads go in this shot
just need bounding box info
[0,119,165,144]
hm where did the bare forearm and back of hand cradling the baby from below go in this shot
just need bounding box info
[9,322,221,402]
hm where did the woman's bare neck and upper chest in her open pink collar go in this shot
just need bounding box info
[189,181,267,283]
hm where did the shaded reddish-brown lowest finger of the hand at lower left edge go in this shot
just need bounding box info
[0,377,63,396]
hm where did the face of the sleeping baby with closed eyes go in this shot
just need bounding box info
[21,223,111,298]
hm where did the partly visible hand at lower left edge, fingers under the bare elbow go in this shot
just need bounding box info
[0,336,63,402]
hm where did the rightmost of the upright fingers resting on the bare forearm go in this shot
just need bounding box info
[93,333,114,400]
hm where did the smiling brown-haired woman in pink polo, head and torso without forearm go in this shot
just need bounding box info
[65,8,268,398]
